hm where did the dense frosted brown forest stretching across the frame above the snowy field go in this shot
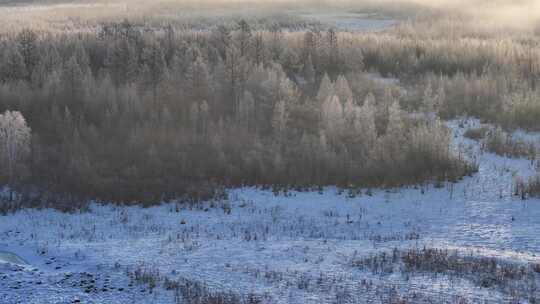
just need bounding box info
[0,8,540,204]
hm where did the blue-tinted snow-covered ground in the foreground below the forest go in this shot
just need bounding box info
[0,120,540,303]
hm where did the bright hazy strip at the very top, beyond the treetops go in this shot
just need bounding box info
[0,0,540,29]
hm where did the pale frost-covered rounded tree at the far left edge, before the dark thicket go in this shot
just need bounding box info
[0,111,31,200]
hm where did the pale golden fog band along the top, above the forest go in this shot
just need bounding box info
[0,0,540,29]
